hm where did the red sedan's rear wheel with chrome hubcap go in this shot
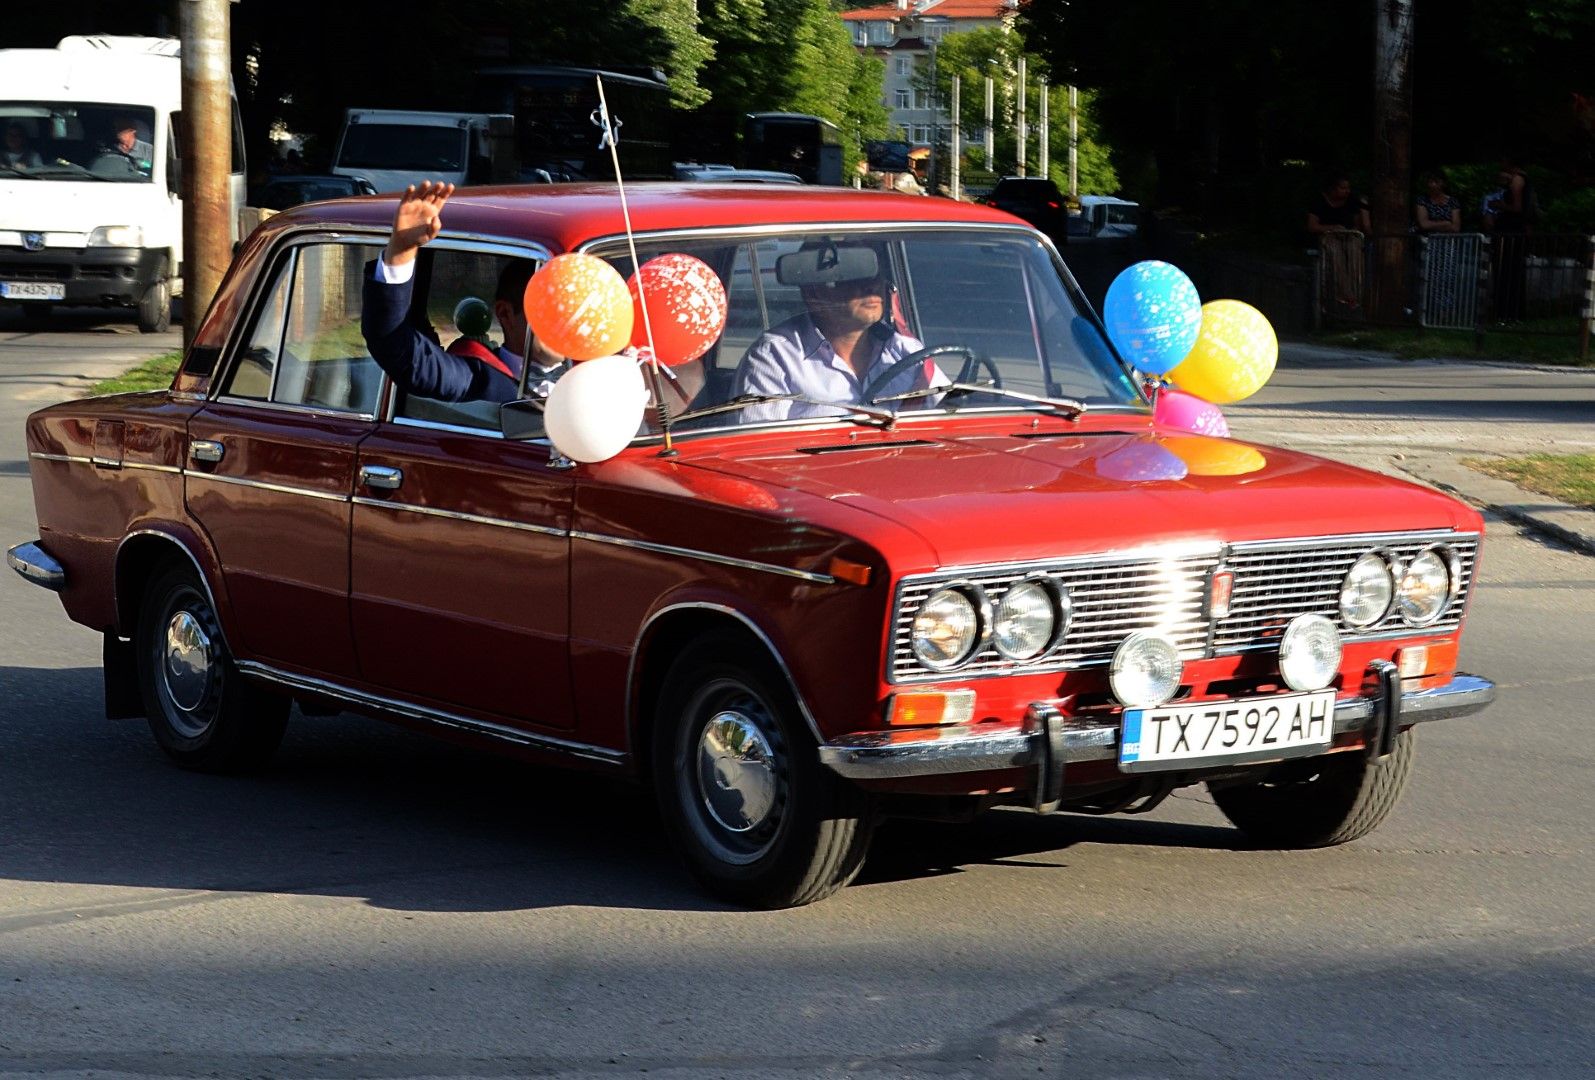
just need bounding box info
[134,563,289,772]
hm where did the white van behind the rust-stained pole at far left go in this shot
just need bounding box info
[0,37,244,330]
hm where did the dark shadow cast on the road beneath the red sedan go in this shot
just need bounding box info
[0,667,1238,911]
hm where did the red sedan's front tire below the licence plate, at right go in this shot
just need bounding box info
[1209,729,1413,849]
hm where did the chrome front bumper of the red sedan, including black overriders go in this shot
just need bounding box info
[820,660,1495,785]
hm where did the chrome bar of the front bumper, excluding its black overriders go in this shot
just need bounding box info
[820,672,1496,780]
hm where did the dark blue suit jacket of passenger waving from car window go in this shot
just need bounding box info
[360,262,522,402]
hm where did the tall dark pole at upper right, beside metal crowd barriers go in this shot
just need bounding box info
[1372,0,1413,317]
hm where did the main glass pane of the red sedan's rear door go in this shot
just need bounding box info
[271,242,383,413]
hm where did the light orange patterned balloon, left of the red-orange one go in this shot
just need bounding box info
[525,252,632,361]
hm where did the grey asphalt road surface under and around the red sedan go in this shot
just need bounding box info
[0,315,1595,1078]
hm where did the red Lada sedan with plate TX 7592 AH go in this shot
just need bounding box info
[10,183,1495,906]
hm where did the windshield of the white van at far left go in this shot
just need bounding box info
[0,101,155,183]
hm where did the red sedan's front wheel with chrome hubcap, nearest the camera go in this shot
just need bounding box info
[652,633,874,908]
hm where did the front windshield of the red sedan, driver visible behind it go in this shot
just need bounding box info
[601,228,1145,431]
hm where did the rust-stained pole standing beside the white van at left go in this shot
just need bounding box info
[181,0,233,345]
